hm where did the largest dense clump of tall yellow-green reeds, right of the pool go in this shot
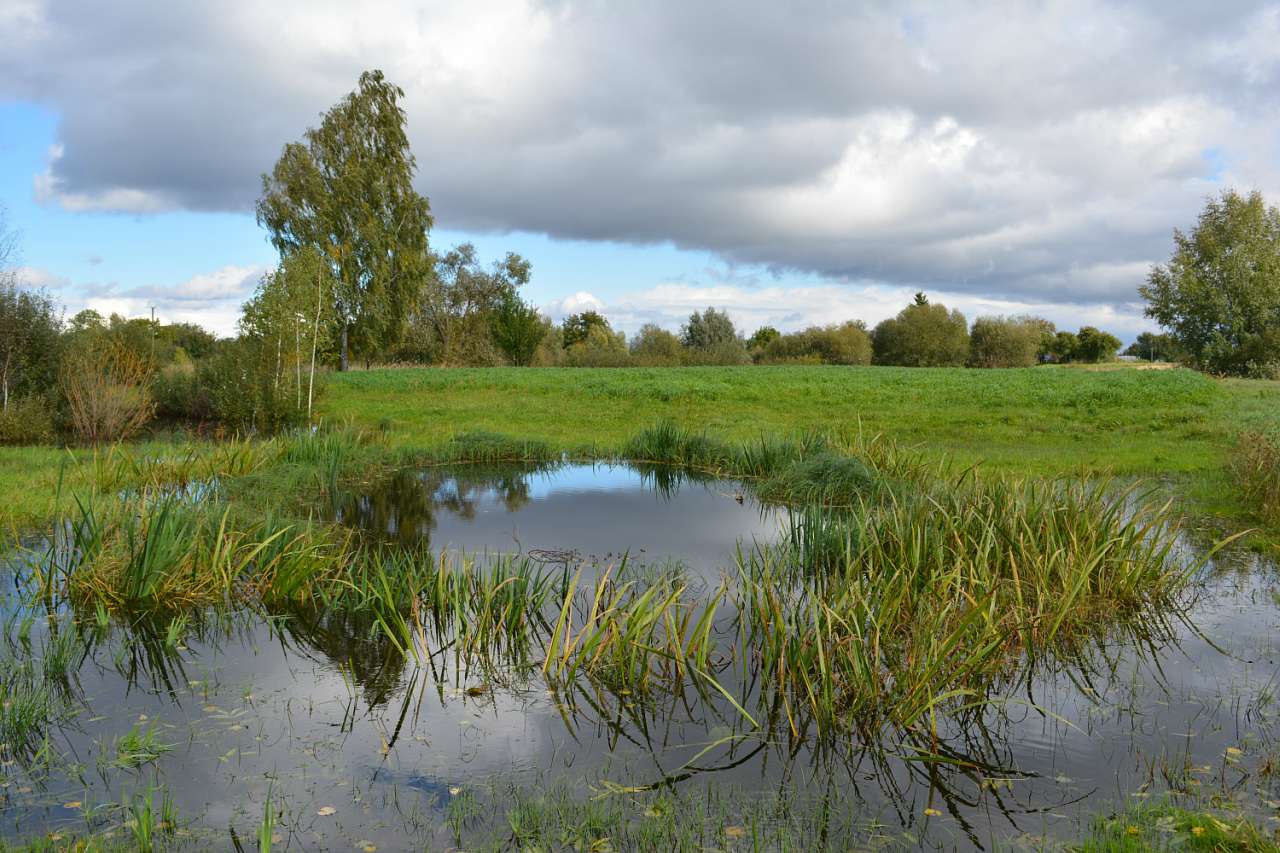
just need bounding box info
[737,475,1207,735]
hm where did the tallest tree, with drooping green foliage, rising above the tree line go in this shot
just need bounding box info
[257,70,431,370]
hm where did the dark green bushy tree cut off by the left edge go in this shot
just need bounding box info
[0,280,61,411]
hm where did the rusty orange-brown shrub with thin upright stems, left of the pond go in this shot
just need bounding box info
[61,338,155,444]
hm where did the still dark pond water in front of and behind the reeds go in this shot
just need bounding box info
[0,466,1280,850]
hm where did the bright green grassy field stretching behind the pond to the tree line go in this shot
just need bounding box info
[0,366,1280,535]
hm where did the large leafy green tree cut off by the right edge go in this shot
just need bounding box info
[1138,190,1280,375]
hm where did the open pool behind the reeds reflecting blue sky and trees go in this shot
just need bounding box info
[333,465,787,578]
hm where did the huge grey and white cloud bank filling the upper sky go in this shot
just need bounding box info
[0,0,1280,305]
